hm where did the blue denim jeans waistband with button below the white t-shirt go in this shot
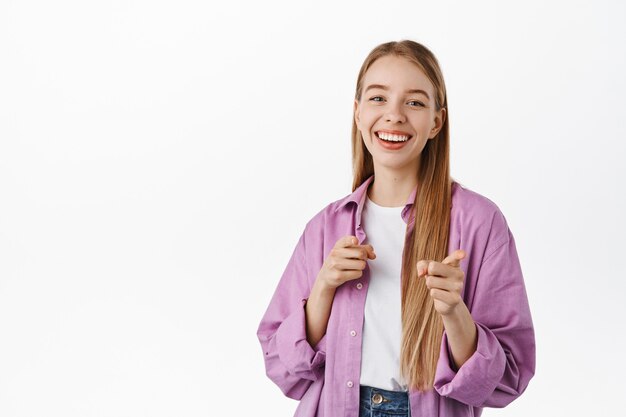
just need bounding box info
[359,385,411,417]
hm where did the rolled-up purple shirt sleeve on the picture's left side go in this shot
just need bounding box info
[257,229,326,400]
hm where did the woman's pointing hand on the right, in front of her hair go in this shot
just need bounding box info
[417,249,466,316]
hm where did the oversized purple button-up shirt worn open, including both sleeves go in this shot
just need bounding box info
[257,175,535,417]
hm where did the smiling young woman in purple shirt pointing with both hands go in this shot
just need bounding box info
[257,40,535,417]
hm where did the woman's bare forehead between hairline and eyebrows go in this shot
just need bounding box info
[363,55,433,97]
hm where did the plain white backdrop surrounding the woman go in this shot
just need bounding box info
[0,0,626,417]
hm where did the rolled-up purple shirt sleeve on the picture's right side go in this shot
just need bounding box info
[434,214,535,407]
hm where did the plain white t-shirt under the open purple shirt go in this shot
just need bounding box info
[360,196,407,391]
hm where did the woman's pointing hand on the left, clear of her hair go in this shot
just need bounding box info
[317,236,376,289]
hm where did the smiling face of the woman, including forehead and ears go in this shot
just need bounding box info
[354,55,445,176]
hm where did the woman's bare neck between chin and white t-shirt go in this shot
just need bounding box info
[367,164,417,207]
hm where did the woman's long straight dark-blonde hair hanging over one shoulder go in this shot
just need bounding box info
[352,40,452,391]
